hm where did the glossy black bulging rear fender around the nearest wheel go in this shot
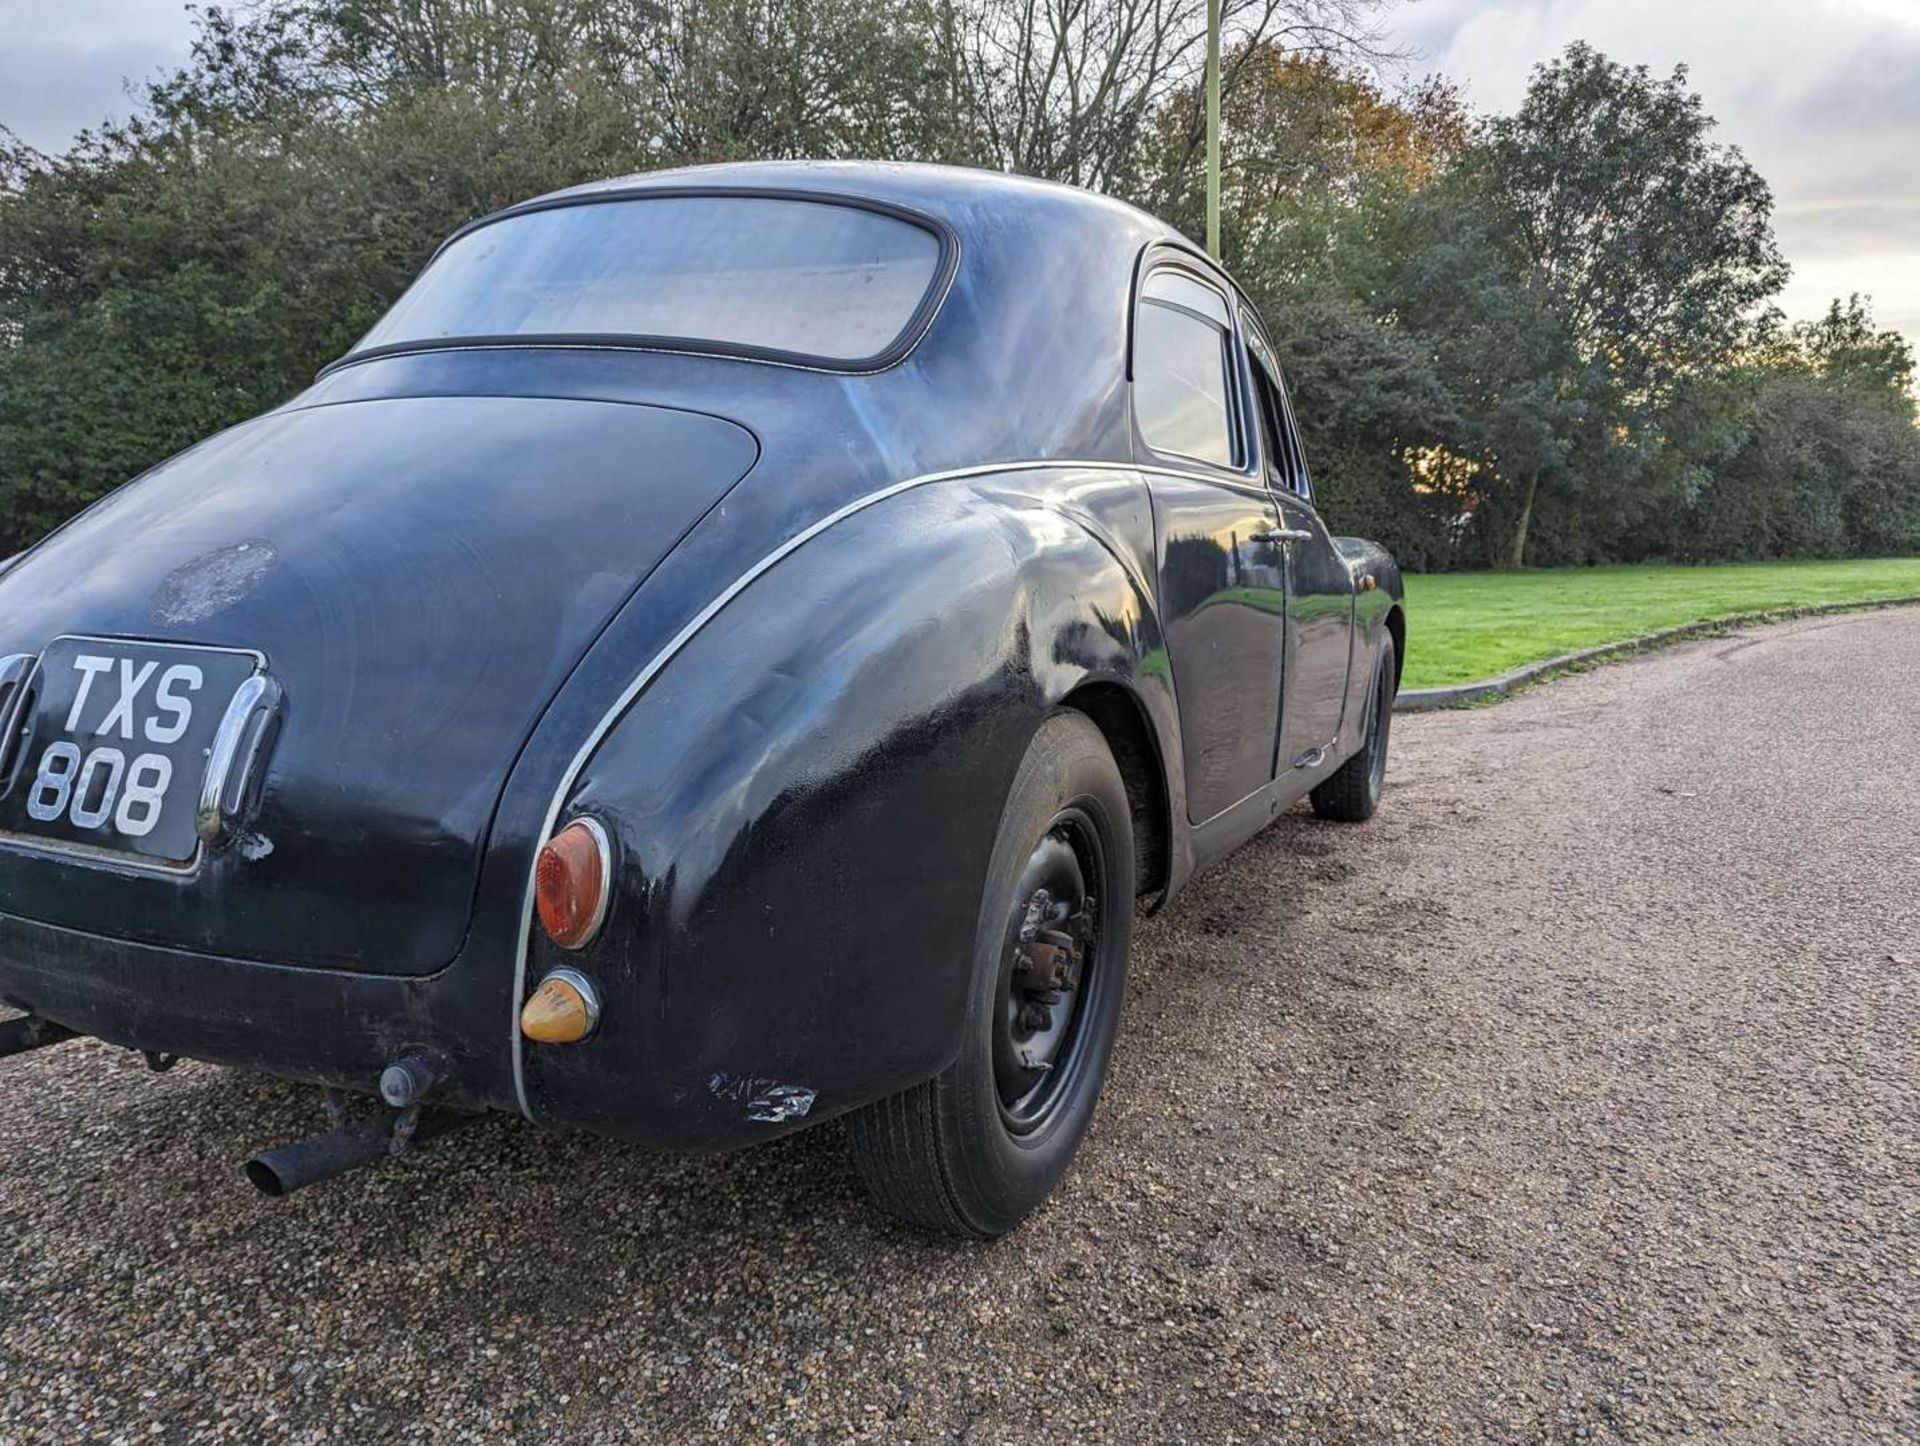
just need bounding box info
[522,469,1185,1148]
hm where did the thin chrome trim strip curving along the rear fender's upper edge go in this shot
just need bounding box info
[507,461,1159,1120]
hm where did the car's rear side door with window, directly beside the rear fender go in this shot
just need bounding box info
[1133,263,1286,824]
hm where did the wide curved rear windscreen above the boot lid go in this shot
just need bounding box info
[355,196,943,365]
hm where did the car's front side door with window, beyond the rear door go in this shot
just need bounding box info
[1242,311,1354,774]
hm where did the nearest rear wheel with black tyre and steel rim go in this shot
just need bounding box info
[851,712,1135,1239]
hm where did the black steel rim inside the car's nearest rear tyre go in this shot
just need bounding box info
[993,805,1108,1135]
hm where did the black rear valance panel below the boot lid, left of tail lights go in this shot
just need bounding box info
[0,914,518,1110]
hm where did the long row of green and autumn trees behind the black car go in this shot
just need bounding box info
[0,14,1920,566]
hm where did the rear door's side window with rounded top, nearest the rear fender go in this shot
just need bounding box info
[1133,269,1240,467]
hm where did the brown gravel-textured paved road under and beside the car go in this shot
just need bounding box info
[0,611,1920,1442]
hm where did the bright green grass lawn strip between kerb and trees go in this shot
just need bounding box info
[1402,557,1920,687]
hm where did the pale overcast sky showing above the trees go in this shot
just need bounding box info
[0,0,1920,342]
